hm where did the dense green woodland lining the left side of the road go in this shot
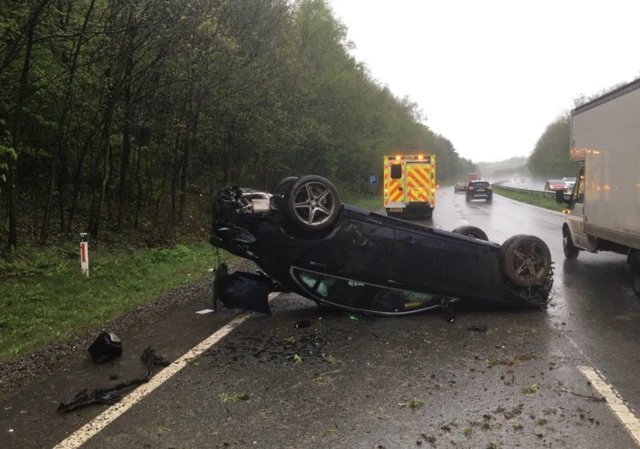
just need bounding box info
[0,0,473,247]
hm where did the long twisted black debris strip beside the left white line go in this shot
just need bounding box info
[58,347,169,412]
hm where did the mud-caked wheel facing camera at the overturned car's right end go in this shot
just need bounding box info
[500,234,551,287]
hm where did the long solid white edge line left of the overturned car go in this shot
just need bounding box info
[54,292,280,449]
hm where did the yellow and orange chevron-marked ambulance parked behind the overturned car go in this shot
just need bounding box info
[384,154,436,218]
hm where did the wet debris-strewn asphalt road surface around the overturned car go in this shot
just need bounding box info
[0,188,640,449]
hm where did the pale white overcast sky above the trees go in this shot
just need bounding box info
[330,0,640,162]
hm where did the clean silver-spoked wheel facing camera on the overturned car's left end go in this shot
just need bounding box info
[286,175,341,231]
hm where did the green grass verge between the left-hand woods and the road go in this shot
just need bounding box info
[0,244,226,361]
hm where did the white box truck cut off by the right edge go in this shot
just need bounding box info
[556,80,640,296]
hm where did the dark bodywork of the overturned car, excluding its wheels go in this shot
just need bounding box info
[210,189,552,315]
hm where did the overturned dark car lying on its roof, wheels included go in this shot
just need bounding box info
[210,176,553,315]
